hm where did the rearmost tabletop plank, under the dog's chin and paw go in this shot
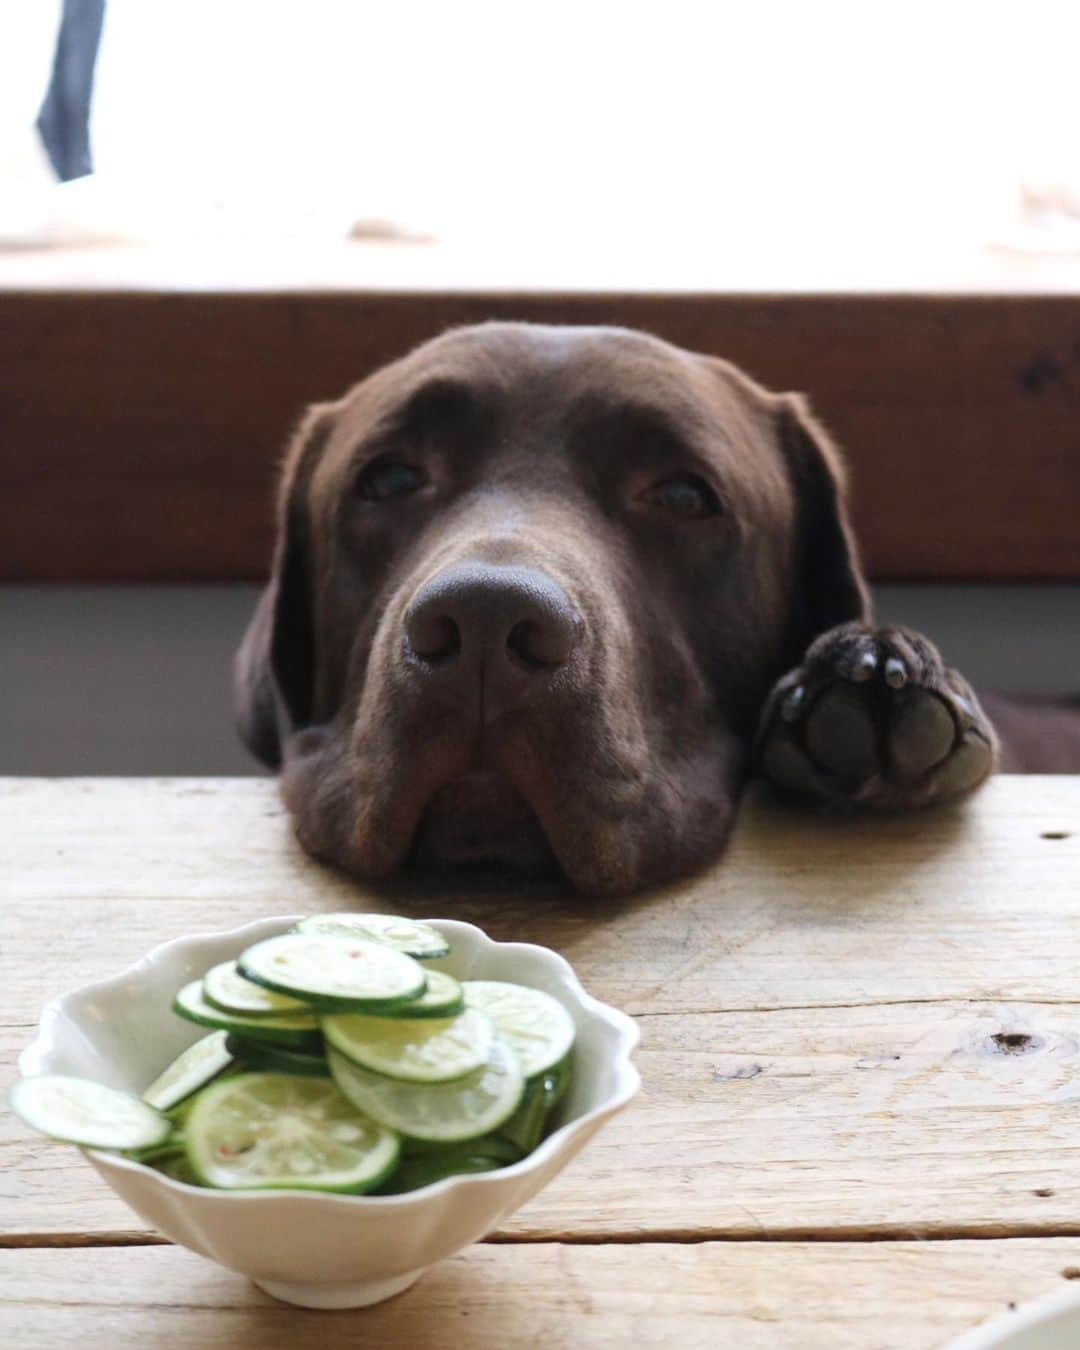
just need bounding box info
[0,776,1080,1021]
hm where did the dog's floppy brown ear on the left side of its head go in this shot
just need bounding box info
[232,404,333,768]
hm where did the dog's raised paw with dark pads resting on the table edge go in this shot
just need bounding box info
[755,624,996,807]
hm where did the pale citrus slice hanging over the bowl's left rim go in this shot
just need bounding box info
[8,1073,173,1149]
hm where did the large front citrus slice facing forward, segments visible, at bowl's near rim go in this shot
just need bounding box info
[186,1073,401,1195]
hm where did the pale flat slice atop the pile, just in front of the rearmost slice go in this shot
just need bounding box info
[236,933,428,1013]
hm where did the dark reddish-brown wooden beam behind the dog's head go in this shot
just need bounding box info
[0,285,1080,582]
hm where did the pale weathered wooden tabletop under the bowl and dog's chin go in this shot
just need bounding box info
[0,778,1080,1350]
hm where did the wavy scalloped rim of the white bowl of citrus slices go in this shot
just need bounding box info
[18,911,641,1210]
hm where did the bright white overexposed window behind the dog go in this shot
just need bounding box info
[0,0,1080,271]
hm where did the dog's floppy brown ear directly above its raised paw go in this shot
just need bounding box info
[776,394,871,664]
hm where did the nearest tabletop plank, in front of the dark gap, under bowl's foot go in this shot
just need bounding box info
[0,1239,1080,1350]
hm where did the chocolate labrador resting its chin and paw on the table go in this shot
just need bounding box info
[236,324,1080,895]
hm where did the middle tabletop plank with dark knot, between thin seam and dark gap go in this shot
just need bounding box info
[8,1003,1080,1245]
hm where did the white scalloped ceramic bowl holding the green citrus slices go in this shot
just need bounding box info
[19,915,641,1308]
